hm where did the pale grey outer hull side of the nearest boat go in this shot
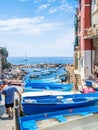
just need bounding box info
[43,115,98,130]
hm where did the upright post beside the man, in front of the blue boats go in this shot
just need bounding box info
[14,99,19,130]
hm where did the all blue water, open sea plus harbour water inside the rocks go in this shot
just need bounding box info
[7,57,73,81]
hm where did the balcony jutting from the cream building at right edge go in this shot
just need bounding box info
[84,26,98,39]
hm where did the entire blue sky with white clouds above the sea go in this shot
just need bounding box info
[0,0,76,57]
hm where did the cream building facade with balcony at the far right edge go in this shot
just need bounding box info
[89,0,98,64]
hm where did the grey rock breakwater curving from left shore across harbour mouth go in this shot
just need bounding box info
[2,63,65,84]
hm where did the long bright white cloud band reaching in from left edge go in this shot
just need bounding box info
[0,16,47,34]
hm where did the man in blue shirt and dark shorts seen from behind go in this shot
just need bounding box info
[1,82,21,117]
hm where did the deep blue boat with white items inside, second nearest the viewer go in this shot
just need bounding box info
[22,93,98,115]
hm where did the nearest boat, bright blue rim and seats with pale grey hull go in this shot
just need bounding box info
[19,106,98,130]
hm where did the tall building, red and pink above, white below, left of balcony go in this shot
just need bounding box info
[74,0,95,79]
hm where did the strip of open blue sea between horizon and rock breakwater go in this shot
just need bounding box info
[7,57,74,65]
